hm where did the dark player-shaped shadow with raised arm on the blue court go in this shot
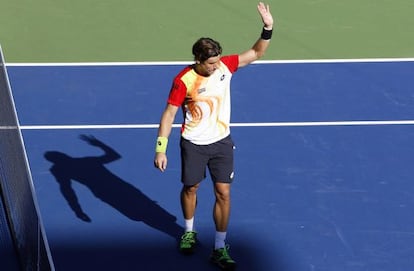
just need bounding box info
[44,135,183,239]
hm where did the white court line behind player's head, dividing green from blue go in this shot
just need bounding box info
[5,58,414,67]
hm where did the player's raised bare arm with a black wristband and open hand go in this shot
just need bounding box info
[239,2,273,67]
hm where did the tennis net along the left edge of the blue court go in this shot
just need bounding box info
[0,46,54,271]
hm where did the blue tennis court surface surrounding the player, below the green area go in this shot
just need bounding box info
[8,60,414,271]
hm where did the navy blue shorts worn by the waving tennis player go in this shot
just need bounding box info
[180,135,235,185]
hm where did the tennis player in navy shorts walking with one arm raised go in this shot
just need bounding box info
[154,2,273,270]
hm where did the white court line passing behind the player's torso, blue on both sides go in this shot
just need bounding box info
[20,120,414,130]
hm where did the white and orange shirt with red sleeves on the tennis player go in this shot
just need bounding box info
[168,55,239,145]
